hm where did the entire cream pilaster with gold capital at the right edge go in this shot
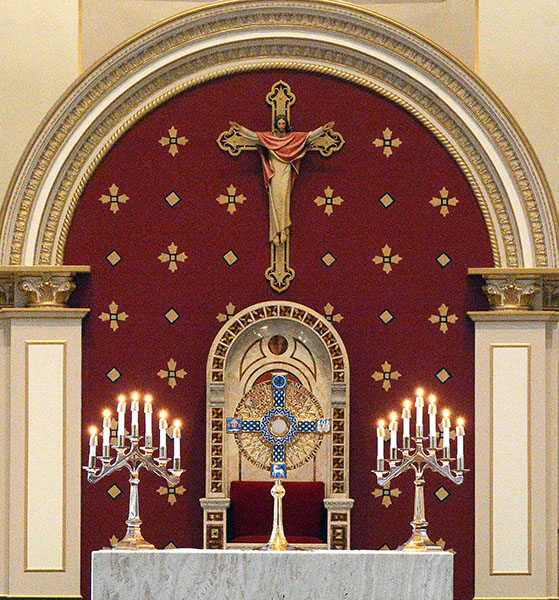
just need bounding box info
[468,268,559,599]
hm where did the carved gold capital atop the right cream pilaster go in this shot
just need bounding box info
[468,268,559,312]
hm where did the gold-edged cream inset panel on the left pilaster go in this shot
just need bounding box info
[25,341,66,571]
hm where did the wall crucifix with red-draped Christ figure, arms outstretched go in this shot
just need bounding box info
[217,81,344,293]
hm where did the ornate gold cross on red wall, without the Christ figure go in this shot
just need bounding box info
[217,80,344,292]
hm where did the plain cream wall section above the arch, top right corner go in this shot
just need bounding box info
[479,0,559,209]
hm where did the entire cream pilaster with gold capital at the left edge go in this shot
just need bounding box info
[0,265,89,598]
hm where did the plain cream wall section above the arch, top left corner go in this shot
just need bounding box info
[0,0,79,206]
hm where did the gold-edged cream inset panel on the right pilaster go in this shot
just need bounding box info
[490,344,531,575]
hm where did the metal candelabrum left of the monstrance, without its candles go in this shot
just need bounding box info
[83,424,184,550]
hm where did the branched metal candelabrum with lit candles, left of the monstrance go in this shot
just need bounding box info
[83,394,184,550]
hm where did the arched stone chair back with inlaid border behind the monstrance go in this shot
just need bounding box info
[200,301,353,549]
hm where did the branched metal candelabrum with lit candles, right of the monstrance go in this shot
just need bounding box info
[372,390,469,552]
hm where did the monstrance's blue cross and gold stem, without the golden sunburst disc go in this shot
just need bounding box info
[227,372,330,550]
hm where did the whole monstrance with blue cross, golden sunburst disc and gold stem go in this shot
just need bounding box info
[227,372,330,550]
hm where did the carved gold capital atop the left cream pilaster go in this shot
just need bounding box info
[0,265,90,308]
